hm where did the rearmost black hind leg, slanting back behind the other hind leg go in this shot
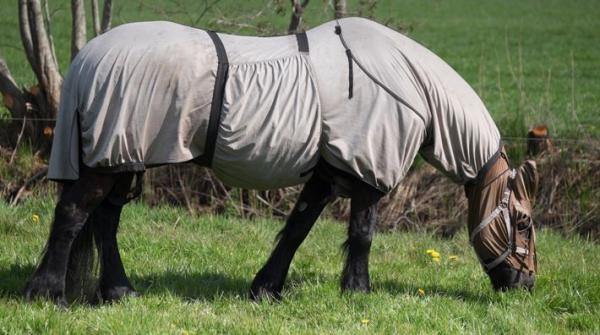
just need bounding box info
[25,168,116,305]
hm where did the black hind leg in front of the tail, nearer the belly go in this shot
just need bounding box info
[92,173,137,302]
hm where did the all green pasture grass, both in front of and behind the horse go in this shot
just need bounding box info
[0,0,600,334]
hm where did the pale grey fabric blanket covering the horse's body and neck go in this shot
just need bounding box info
[48,18,500,192]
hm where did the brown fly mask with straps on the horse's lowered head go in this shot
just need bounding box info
[465,151,538,290]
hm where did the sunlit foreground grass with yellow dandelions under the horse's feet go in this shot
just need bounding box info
[0,197,600,334]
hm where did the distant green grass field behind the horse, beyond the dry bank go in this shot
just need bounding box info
[0,0,600,139]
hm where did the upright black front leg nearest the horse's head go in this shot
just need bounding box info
[341,181,382,292]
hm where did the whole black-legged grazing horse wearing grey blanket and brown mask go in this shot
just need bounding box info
[25,18,537,304]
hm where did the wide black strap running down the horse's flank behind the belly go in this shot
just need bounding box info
[199,31,229,167]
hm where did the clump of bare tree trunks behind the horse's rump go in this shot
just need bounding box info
[0,0,112,154]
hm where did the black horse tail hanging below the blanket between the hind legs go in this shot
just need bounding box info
[65,212,102,303]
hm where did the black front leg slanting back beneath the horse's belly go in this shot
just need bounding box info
[250,176,333,300]
